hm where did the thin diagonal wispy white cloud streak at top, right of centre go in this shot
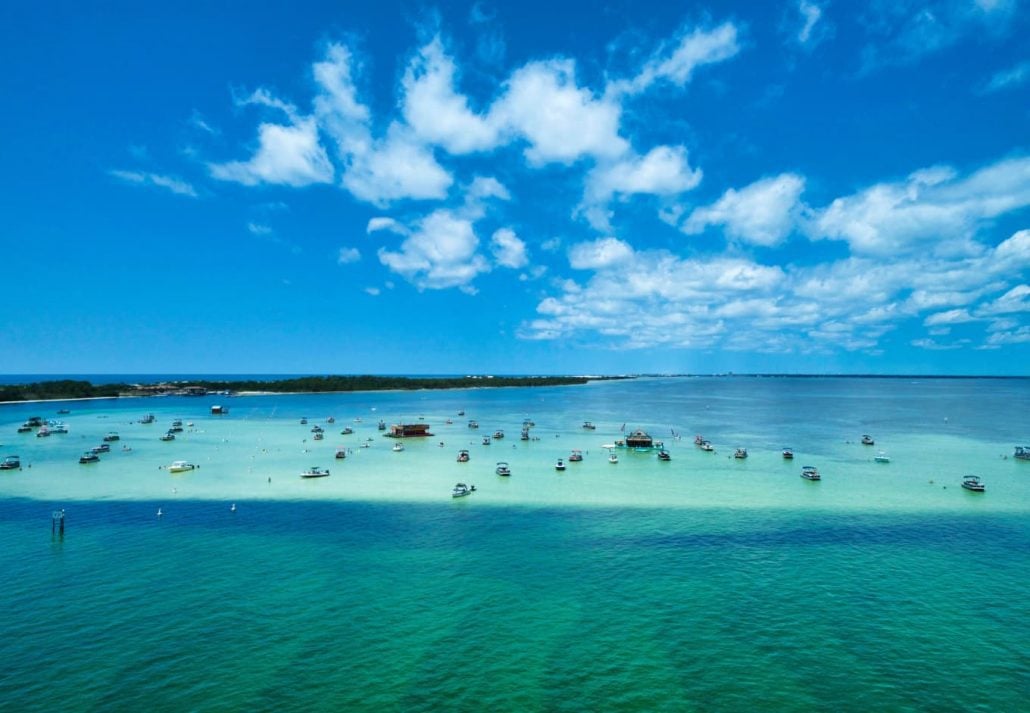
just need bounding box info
[608,23,740,96]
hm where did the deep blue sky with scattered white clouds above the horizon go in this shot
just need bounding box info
[0,0,1030,374]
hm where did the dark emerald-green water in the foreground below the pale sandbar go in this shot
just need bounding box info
[0,502,1030,711]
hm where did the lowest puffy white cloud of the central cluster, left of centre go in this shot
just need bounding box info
[378,209,490,290]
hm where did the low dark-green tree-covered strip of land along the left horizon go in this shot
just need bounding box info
[0,375,605,403]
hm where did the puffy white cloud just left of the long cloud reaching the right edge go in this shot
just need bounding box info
[682,173,804,246]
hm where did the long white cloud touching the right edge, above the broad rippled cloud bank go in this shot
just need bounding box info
[810,158,1030,256]
